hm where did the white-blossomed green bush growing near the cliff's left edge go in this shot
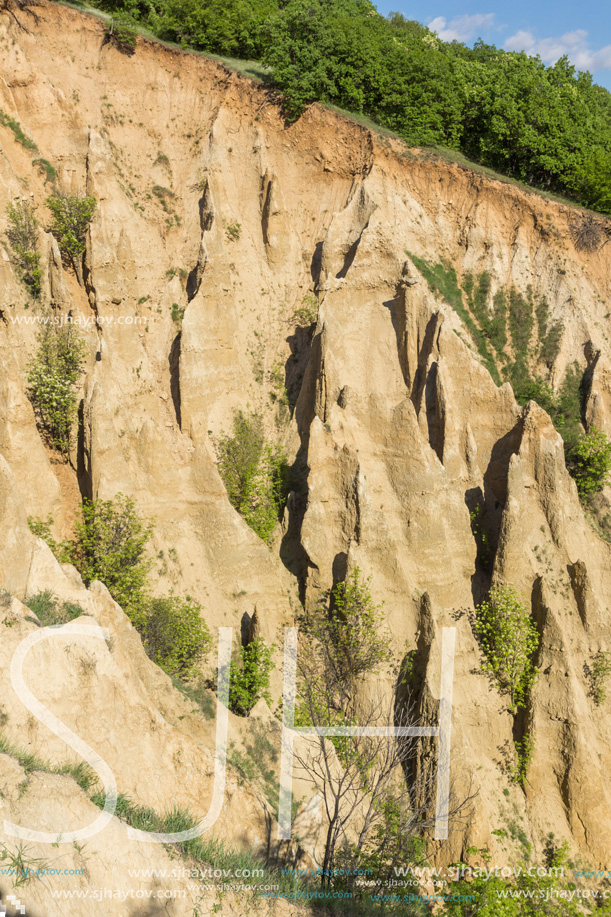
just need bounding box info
[27,316,85,454]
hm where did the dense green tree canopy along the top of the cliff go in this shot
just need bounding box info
[97,0,611,212]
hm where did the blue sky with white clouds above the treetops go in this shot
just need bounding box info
[374,0,611,90]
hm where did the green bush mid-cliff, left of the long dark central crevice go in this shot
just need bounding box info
[218,411,288,544]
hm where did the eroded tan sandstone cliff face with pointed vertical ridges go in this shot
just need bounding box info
[0,3,611,913]
